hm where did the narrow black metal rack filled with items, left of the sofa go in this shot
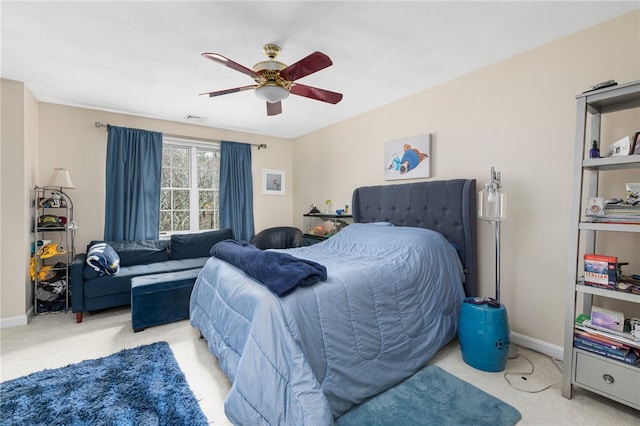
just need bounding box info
[31,186,75,315]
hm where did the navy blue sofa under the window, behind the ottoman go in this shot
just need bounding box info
[70,228,233,323]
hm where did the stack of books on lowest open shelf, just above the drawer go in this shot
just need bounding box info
[573,315,640,367]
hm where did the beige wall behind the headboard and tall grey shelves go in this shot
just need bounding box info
[294,12,640,347]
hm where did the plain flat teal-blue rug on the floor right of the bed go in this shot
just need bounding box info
[336,365,522,426]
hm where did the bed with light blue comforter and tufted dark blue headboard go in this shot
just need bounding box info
[190,179,477,425]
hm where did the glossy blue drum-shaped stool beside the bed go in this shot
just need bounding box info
[458,298,510,372]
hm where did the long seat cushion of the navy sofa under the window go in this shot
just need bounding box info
[84,256,209,299]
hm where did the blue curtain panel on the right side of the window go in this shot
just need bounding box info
[220,141,254,241]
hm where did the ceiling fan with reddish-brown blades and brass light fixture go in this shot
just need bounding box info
[201,44,342,115]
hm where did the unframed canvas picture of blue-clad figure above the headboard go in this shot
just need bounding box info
[384,134,431,180]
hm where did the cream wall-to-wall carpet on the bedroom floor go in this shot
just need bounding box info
[0,308,640,426]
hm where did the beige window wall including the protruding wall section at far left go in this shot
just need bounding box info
[0,94,295,328]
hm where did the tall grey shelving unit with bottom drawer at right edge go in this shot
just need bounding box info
[562,81,640,409]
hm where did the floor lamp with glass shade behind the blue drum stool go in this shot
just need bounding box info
[478,166,518,358]
